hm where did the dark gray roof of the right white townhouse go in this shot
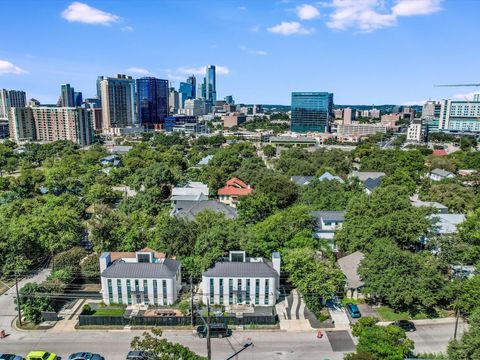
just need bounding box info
[203,261,278,278]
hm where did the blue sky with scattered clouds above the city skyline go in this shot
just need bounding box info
[0,0,480,104]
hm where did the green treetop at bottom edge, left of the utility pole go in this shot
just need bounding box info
[130,328,206,360]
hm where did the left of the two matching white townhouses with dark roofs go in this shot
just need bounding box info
[100,248,182,306]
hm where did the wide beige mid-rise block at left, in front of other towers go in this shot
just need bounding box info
[9,106,93,146]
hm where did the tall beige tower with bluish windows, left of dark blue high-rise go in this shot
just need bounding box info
[100,74,136,132]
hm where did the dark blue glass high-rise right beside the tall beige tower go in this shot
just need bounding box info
[137,77,169,128]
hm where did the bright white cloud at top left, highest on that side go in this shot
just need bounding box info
[62,1,120,26]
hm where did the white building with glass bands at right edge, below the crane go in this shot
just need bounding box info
[438,100,480,131]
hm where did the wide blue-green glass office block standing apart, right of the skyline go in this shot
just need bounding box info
[291,92,333,132]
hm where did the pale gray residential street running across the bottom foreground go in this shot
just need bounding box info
[0,324,463,360]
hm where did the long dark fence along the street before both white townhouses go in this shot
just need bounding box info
[79,315,277,326]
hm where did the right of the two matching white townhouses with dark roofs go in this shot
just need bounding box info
[202,251,281,306]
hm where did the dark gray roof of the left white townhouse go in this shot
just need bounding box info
[102,259,180,279]
